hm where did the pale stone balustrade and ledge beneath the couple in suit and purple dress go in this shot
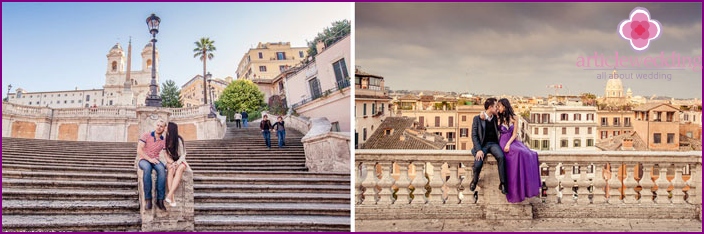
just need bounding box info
[354,150,702,231]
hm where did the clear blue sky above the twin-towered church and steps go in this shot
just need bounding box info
[0,2,352,97]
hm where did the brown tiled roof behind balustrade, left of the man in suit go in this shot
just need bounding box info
[364,117,447,150]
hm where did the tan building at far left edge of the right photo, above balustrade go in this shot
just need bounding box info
[354,69,394,149]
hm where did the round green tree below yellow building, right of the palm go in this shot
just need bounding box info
[215,80,267,120]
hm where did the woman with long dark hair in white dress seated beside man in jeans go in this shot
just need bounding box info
[165,122,189,207]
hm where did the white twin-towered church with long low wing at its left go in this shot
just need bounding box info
[8,42,159,108]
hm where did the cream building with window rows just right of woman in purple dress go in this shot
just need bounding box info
[523,106,597,151]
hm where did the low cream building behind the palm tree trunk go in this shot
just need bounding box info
[180,75,232,107]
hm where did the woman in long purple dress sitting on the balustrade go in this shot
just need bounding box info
[497,98,541,203]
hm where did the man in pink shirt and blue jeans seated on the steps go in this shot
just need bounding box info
[137,119,166,210]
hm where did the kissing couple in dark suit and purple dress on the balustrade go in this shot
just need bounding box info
[469,98,541,203]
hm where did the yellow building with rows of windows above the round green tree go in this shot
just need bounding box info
[237,42,308,80]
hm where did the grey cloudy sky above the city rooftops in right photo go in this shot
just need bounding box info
[355,3,702,98]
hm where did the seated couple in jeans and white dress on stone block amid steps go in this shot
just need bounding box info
[137,119,189,210]
